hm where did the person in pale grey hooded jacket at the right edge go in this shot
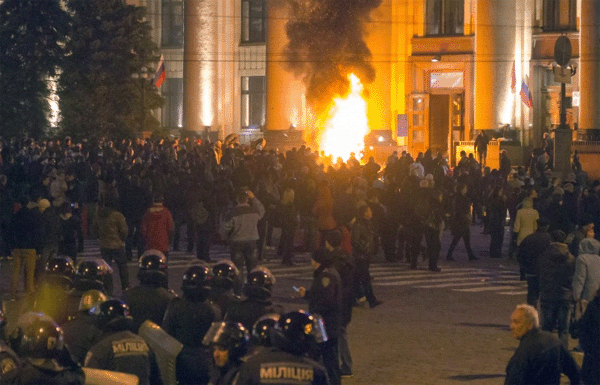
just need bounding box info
[573,238,600,302]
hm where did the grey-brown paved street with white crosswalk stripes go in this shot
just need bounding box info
[0,227,575,385]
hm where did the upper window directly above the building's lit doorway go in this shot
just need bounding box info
[425,0,465,35]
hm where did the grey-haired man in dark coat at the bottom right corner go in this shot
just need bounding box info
[504,305,580,385]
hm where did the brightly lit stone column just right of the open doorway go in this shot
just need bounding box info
[474,0,516,135]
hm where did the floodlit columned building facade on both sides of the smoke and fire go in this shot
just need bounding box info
[138,0,600,160]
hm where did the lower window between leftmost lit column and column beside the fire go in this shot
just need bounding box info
[242,76,267,128]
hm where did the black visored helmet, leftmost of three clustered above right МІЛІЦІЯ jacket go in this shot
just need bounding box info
[202,322,250,361]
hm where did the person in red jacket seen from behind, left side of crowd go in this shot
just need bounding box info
[140,195,175,257]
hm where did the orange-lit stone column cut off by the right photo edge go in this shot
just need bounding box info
[578,0,600,130]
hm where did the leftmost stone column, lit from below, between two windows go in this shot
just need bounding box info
[183,0,218,132]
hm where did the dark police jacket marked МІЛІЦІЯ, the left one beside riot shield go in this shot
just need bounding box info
[85,330,161,385]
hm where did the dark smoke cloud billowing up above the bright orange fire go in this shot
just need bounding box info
[284,0,381,112]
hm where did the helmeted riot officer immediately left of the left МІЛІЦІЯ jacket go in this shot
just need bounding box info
[10,312,85,385]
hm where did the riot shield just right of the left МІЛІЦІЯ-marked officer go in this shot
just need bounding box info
[138,320,183,385]
